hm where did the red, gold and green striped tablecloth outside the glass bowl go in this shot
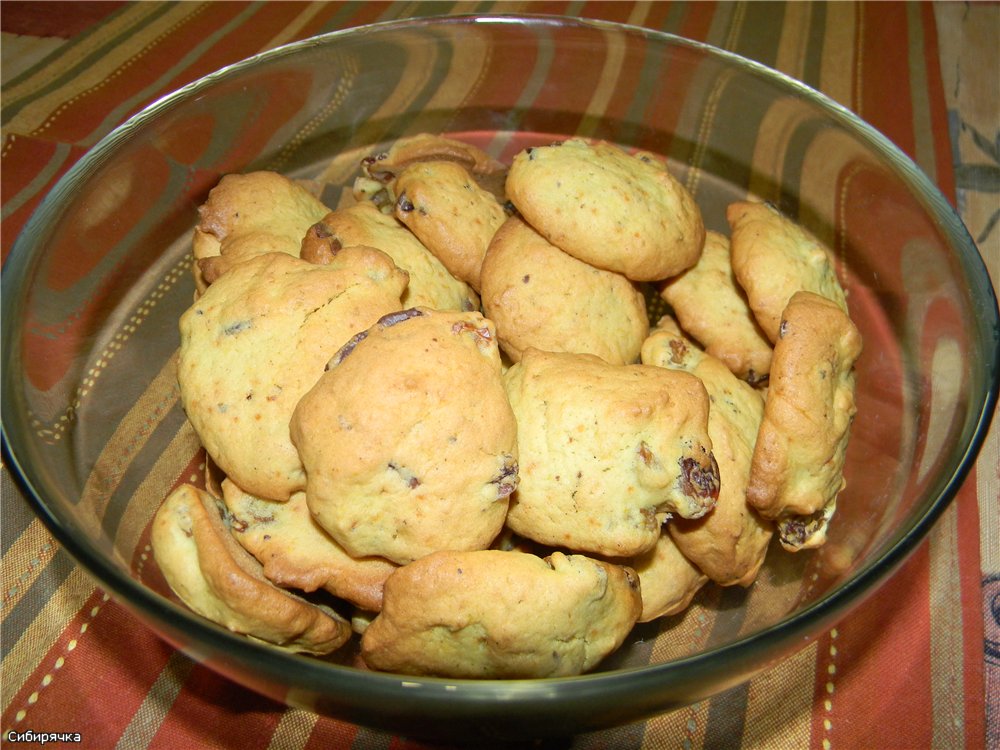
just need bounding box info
[0,0,1000,750]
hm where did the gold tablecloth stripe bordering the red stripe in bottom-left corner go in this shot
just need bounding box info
[0,567,97,712]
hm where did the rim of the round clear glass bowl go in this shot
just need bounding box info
[0,8,1000,708]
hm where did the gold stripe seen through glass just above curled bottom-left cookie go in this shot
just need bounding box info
[115,420,201,561]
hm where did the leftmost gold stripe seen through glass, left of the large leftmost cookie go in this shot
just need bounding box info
[80,352,180,518]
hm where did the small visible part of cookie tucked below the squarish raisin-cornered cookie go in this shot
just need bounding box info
[623,536,709,622]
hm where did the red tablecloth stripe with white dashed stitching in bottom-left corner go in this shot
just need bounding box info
[3,591,173,747]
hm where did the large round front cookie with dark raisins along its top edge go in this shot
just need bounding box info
[291,308,517,564]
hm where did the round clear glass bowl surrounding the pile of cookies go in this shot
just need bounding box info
[2,16,998,740]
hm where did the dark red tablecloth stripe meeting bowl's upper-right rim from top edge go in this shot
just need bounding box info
[857,3,916,158]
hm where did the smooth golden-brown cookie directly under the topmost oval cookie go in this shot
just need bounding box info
[481,217,649,364]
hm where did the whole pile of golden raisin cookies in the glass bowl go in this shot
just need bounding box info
[152,135,861,678]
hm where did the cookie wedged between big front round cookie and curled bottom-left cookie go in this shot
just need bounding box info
[222,479,396,612]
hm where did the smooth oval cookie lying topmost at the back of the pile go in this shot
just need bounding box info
[506,138,705,281]
